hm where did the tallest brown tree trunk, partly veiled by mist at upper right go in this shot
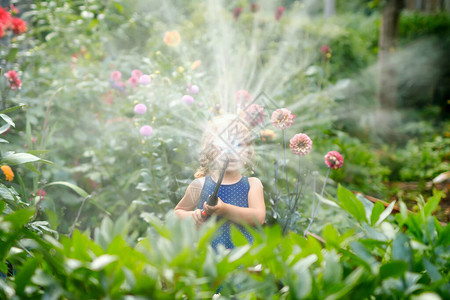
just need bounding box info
[376,0,403,136]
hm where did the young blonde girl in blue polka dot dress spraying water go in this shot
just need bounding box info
[175,114,266,249]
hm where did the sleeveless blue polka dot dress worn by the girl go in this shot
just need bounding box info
[198,176,253,250]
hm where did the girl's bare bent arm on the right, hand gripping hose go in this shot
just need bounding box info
[204,177,266,225]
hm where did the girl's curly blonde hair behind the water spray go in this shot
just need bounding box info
[194,114,255,178]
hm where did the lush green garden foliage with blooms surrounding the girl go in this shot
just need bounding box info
[0,0,450,299]
